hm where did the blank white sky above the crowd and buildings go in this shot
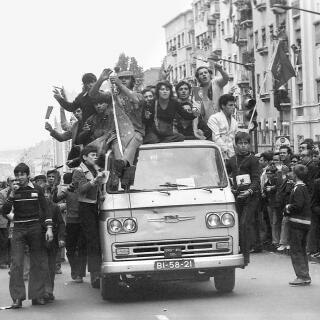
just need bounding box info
[0,0,191,151]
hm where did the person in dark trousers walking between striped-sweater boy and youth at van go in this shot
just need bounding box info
[53,172,87,283]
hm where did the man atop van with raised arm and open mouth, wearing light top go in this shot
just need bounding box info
[195,63,229,123]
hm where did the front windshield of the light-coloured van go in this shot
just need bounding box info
[131,147,227,191]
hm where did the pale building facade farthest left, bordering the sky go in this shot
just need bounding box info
[163,9,194,83]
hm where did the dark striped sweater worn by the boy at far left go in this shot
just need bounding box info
[2,182,52,225]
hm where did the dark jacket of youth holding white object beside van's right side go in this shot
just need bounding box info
[227,153,260,195]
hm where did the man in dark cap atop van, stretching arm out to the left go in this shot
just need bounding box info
[53,73,97,122]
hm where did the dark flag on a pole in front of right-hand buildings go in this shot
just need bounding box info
[269,40,296,90]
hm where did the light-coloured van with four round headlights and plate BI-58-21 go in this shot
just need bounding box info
[100,140,244,299]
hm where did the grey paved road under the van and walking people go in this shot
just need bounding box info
[0,253,320,320]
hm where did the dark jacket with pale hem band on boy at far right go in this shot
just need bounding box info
[286,182,311,228]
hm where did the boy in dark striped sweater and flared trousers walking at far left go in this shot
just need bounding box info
[2,163,53,308]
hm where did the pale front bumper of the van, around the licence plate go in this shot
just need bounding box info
[101,254,244,274]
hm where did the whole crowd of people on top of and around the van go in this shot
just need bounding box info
[0,64,320,308]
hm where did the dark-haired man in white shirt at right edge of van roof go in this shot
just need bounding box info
[208,94,238,159]
